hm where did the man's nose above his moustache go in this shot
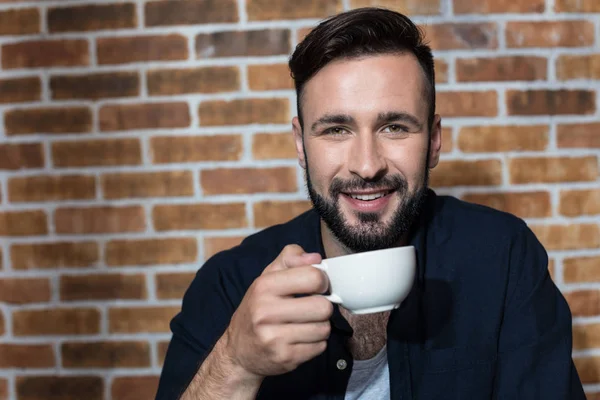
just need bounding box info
[348,133,387,181]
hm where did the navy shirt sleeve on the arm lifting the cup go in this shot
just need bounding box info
[156,255,239,400]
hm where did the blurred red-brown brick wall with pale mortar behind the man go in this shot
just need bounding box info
[0,0,600,400]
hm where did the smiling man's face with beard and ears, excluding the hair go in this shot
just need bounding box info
[293,54,441,252]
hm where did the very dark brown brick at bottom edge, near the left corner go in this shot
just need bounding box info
[16,375,104,400]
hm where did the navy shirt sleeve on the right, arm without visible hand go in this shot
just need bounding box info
[493,226,585,400]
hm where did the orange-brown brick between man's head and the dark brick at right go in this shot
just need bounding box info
[436,90,498,118]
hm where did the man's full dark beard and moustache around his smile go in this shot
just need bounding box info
[306,164,429,253]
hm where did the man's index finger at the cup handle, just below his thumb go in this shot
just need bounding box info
[261,265,329,296]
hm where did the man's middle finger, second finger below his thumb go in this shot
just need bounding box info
[264,296,333,324]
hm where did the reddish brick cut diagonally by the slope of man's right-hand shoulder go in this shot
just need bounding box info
[463,192,552,218]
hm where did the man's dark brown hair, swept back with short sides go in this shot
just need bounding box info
[289,7,435,129]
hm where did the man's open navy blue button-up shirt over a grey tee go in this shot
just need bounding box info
[156,191,585,400]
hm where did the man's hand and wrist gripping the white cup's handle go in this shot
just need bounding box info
[221,245,333,378]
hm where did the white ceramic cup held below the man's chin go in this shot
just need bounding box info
[313,246,417,314]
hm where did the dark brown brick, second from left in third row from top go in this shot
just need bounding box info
[50,71,140,100]
